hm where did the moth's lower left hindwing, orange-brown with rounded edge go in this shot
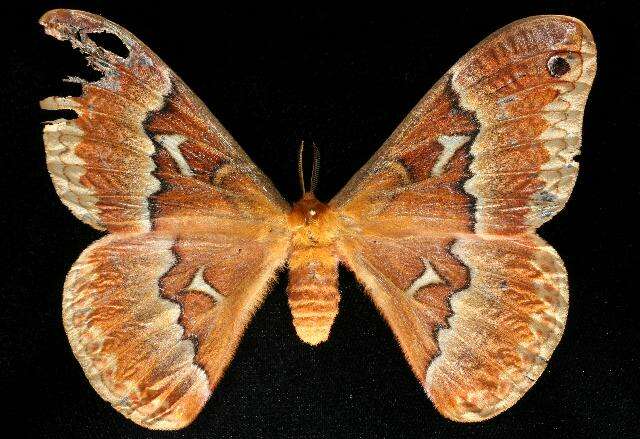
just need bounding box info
[63,233,287,430]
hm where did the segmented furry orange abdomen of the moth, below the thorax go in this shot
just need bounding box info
[287,247,340,345]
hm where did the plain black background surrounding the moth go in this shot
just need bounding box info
[0,1,640,438]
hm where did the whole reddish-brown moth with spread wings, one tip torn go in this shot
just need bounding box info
[40,10,596,430]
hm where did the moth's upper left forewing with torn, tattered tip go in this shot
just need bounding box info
[40,10,288,232]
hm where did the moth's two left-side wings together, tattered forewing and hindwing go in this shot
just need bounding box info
[40,10,289,429]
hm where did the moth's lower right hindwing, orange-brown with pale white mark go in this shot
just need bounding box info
[339,231,569,422]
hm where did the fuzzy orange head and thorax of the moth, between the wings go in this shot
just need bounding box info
[289,192,337,247]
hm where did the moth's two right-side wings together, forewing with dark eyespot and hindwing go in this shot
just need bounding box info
[331,16,595,421]
